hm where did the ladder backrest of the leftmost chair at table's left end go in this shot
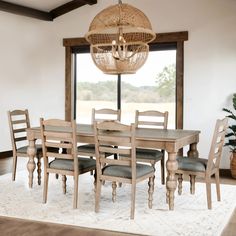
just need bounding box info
[7,109,30,153]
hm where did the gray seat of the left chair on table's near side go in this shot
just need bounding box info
[49,157,96,172]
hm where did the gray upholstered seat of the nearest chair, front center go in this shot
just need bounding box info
[103,164,154,179]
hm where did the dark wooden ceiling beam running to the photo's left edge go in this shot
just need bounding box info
[0,1,53,21]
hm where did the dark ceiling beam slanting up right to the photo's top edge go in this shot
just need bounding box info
[49,0,97,19]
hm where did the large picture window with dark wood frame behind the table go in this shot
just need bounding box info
[63,31,188,129]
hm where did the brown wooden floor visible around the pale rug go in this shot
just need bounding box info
[0,158,236,236]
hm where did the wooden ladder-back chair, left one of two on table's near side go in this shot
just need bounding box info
[40,118,96,208]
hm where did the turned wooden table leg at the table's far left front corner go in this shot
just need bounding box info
[27,139,36,188]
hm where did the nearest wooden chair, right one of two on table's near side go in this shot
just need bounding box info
[94,121,155,219]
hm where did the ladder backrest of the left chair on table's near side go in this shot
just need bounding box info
[40,118,78,174]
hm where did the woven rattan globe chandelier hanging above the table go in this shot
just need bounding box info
[85,0,156,74]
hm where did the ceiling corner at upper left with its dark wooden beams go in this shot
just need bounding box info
[0,0,97,21]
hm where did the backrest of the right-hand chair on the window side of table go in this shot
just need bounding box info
[135,110,169,129]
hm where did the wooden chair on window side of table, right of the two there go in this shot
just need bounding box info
[135,110,168,184]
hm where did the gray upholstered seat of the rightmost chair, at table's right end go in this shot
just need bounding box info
[177,157,208,172]
